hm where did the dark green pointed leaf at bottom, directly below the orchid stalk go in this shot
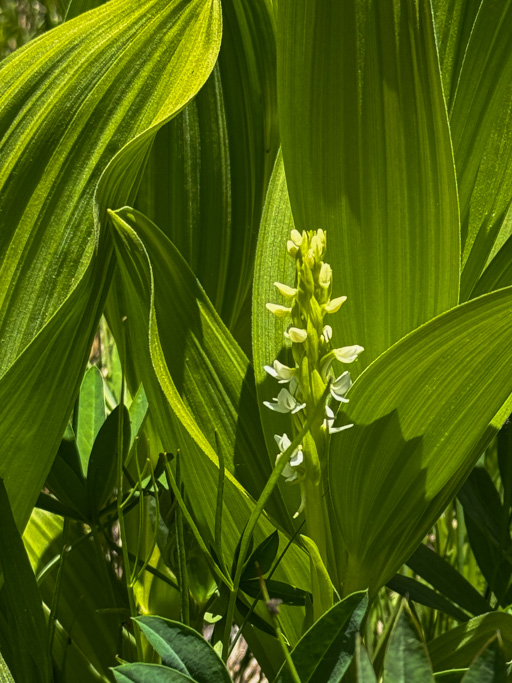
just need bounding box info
[276,592,368,683]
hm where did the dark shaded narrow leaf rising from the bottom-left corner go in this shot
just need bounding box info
[0,478,52,683]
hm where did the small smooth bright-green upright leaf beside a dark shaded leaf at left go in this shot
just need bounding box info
[76,365,105,474]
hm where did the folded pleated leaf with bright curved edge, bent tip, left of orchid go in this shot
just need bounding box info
[111,208,309,616]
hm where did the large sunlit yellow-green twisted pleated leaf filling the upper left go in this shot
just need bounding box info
[0,0,221,524]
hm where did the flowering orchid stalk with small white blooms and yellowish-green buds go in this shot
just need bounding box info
[264,230,363,582]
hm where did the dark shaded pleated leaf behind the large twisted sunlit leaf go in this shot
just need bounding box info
[136,0,278,334]
